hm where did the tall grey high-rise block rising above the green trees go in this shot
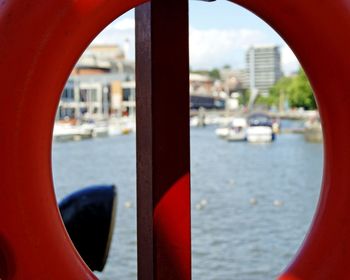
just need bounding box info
[246,46,282,96]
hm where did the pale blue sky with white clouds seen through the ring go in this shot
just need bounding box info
[93,0,299,74]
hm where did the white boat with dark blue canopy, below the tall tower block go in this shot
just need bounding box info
[247,113,275,143]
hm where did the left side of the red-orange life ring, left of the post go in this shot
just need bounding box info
[0,0,143,280]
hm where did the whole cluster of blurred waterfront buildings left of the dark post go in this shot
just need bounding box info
[56,45,135,120]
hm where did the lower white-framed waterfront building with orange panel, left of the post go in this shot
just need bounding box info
[56,73,135,120]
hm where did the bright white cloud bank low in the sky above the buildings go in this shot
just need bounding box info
[89,18,298,73]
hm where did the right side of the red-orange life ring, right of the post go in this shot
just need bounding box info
[230,0,350,280]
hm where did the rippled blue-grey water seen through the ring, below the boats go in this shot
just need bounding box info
[53,123,323,280]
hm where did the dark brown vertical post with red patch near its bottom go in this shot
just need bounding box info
[136,0,191,280]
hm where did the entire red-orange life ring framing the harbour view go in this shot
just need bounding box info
[0,0,350,280]
